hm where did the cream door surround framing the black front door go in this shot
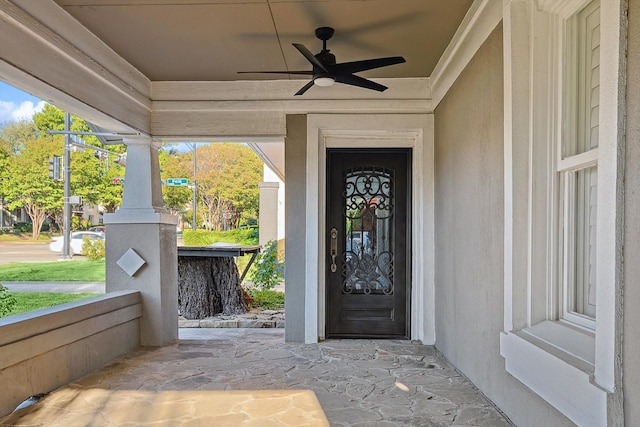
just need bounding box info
[304,114,435,344]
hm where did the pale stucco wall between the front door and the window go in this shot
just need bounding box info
[435,26,572,426]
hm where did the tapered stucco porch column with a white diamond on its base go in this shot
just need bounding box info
[104,138,178,346]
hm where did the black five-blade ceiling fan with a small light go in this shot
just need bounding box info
[239,27,406,95]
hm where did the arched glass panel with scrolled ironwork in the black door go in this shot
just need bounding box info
[342,166,394,295]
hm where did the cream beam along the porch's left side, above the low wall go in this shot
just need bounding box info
[0,0,151,133]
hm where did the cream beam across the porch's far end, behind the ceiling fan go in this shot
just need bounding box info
[151,78,433,141]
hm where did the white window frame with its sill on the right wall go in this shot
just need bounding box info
[500,0,626,425]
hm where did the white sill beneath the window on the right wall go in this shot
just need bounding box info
[500,322,607,425]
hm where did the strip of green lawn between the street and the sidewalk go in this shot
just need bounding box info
[0,259,105,283]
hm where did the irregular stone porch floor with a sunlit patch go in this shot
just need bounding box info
[0,328,512,427]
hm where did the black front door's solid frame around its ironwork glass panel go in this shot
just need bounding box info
[325,147,413,339]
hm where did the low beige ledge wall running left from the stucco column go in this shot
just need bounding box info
[0,291,142,416]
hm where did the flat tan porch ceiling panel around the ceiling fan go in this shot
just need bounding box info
[55,0,472,81]
